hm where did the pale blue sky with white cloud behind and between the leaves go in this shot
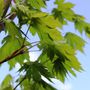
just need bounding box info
[0,0,90,90]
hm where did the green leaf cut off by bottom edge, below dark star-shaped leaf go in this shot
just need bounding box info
[21,79,56,90]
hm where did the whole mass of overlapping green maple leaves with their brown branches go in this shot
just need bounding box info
[0,0,90,90]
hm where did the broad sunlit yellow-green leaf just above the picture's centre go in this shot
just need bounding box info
[30,16,63,41]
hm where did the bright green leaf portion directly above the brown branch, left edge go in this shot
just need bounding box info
[0,36,21,60]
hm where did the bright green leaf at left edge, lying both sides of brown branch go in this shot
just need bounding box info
[0,36,29,69]
